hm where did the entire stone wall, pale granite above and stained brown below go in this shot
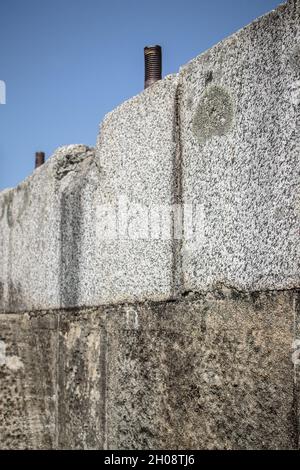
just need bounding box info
[0,0,300,449]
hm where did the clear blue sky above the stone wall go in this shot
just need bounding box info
[0,0,283,190]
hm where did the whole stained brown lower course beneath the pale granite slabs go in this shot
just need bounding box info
[0,288,299,449]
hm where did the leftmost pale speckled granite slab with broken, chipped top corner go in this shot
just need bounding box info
[0,145,98,312]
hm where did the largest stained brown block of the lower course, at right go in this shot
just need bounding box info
[107,289,299,450]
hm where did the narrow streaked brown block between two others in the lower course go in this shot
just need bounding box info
[57,311,107,449]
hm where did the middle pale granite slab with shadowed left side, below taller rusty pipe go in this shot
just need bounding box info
[54,77,177,307]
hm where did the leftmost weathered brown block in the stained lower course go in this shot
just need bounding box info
[0,314,57,449]
